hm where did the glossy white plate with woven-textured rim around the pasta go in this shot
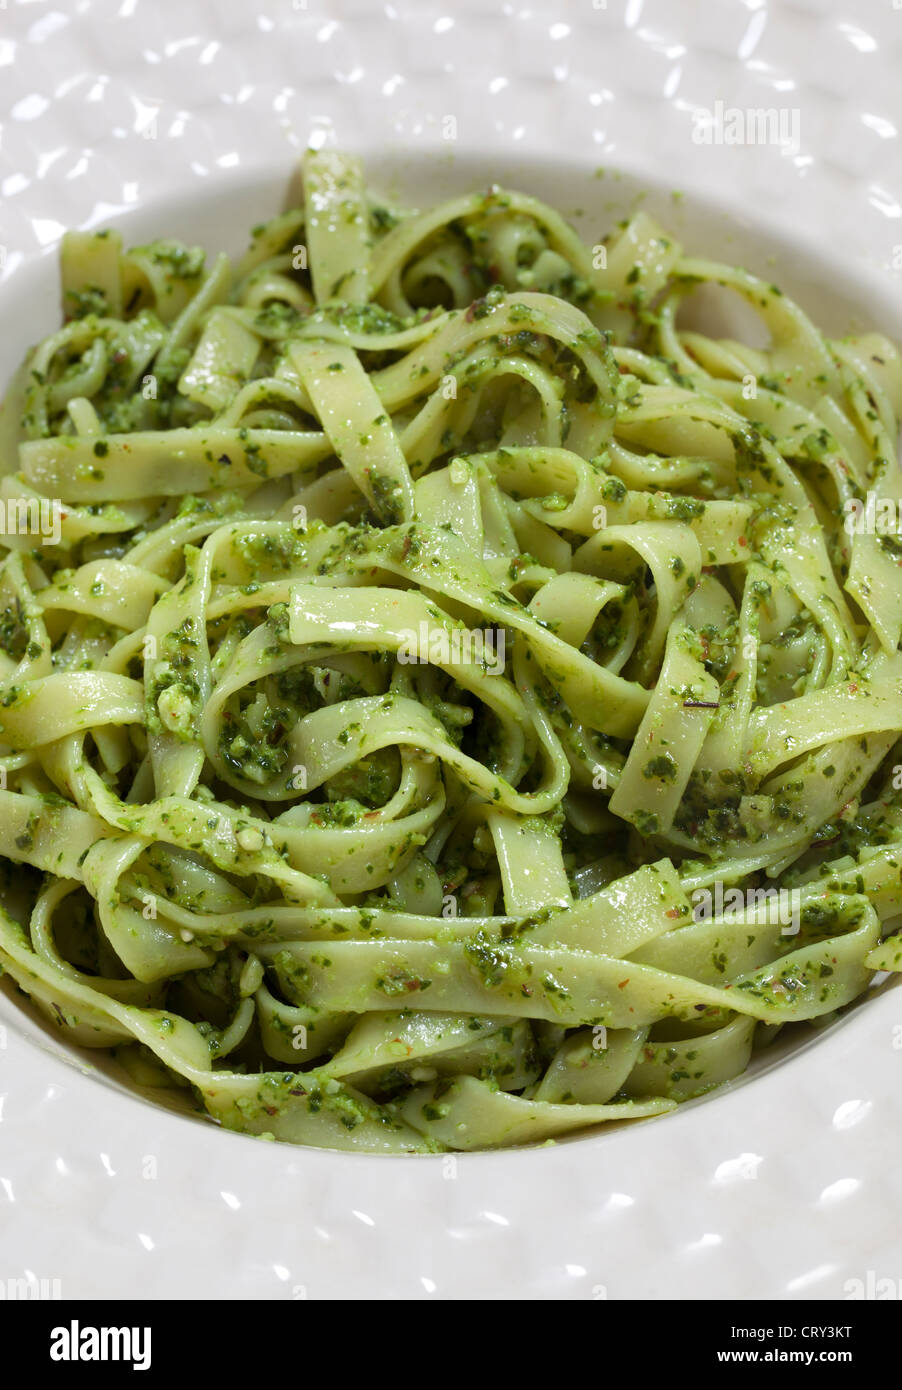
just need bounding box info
[0,0,902,1298]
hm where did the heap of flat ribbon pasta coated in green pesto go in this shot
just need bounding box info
[0,153,902,1154]
